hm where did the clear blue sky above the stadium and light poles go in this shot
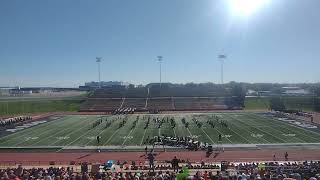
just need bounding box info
[0,0,320,87]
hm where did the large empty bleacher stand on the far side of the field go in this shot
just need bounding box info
[80,85,240,112]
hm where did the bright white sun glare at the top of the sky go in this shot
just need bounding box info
[228,0,269,17]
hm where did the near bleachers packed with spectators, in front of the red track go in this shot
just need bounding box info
[0,162,320,180]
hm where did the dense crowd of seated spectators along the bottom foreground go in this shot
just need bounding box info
[0,162,320,180]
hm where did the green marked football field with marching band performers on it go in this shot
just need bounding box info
[0,113,320,147]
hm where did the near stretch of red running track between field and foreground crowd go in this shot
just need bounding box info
[0,149,320,165]
